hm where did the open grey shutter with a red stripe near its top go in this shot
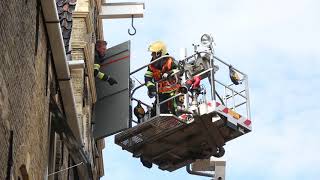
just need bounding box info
[93,41,130,139]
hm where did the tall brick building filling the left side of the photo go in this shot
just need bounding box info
[0,0,104,180]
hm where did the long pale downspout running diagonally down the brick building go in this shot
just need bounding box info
[41,0,81,143]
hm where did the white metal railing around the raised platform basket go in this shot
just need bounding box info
[130,51,251,125]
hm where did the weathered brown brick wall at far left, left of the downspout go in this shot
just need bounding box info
[0,0,51,179]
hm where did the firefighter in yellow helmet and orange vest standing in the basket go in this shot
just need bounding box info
[144,41,181,116]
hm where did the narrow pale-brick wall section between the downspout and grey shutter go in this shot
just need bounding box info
[71,0,104,179]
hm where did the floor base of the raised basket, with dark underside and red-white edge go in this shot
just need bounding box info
[115,102,251,171]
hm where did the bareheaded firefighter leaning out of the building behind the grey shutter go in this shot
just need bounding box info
[94,40,118,86]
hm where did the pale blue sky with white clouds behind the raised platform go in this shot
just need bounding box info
[102,0,320,180]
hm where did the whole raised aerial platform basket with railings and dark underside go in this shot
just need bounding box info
[115,34,251,172]
